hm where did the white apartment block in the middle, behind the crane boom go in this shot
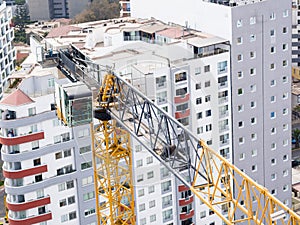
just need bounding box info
[45,19,232,225]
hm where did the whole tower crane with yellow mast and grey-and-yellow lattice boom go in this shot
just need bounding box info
[55,48,300,225]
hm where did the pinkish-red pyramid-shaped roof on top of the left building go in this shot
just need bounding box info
[0,89,34,106]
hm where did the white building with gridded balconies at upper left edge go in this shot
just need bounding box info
[0,0,16,99]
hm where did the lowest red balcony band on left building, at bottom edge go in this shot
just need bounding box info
[8,211,52,225]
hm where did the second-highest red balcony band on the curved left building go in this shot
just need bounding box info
[3,165,48,179]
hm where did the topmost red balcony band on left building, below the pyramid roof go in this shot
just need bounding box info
[0,131,44,145]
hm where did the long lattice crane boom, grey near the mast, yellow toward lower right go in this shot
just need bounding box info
[56,49,300,225]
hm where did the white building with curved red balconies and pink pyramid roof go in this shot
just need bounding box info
[0,55,96,225]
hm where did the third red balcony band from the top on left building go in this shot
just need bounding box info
[6,196,51,212]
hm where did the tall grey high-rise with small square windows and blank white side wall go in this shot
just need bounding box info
[131,0,292,214]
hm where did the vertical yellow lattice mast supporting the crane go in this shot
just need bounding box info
[93,120,135,225]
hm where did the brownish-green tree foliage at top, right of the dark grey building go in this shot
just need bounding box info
[73,0,120,23]
